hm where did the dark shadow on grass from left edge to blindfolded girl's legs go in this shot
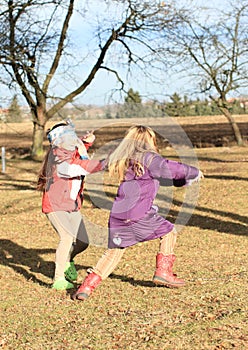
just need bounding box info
[0,239,55,287]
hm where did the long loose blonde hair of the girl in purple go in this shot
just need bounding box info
[108,125,158,181]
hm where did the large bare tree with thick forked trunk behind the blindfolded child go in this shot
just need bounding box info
[0,0,182,157]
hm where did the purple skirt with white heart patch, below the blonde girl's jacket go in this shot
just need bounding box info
[108,206,174,248]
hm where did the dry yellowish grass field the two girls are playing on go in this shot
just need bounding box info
[0,119,248,350]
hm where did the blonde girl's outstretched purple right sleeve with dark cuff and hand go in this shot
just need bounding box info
[147,154,199,187]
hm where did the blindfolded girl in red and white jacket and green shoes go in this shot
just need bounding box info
[37,122,103,290]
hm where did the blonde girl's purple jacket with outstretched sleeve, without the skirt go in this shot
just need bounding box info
[109,152,199,221]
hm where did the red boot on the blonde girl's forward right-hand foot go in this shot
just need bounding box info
[153,253,185,288]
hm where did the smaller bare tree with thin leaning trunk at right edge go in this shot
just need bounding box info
[161,0,248,145]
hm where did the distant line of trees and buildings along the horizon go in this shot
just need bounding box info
[0,89,248,122]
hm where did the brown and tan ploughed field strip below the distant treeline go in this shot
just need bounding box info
[0,115,248,156]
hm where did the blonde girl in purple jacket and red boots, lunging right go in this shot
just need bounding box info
[73,126,203,300]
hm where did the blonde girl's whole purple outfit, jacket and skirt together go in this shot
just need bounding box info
[109,152,199,248]
